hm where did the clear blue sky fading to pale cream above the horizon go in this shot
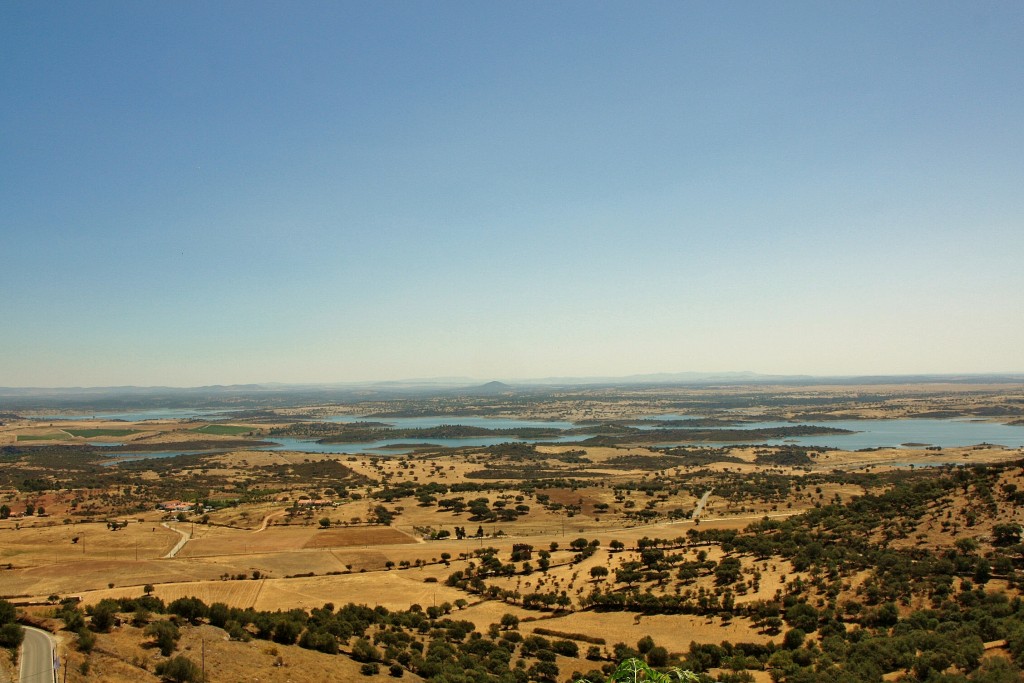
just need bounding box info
[0,0,1024,387]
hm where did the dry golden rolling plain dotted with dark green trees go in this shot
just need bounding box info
[0,383,1024,683]
